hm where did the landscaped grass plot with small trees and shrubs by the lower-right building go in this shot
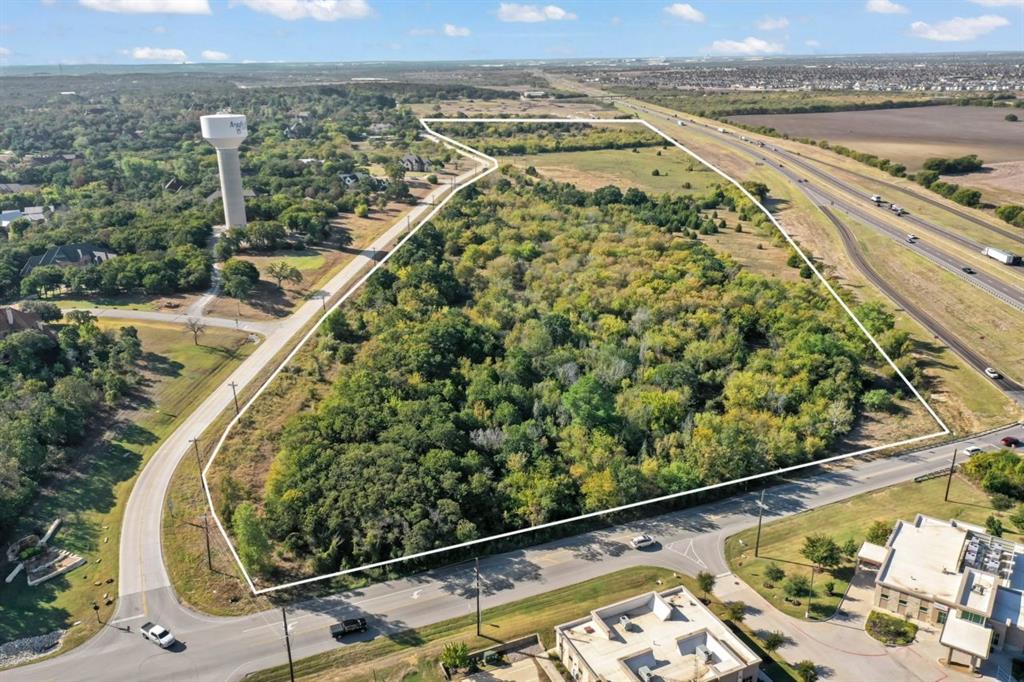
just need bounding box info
[725,474,1024,620]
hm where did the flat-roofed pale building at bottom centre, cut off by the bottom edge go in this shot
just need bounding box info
[555,587,761,682]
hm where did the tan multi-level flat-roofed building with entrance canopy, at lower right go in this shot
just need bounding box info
[858,514,1024,670]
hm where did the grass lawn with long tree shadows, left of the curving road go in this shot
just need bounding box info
[0,318,254,650]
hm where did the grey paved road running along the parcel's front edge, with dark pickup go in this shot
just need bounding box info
[12,425,1024,682]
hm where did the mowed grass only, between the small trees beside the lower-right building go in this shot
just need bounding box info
[725,475,1021,619]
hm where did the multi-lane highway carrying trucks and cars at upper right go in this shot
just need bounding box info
[625,102,1024,312]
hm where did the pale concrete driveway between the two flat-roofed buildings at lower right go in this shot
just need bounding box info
[715,571,995,682]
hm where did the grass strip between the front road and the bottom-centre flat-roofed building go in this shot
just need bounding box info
[247,567,795,682]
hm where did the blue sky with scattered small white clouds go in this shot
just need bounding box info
[0,0,1024,65]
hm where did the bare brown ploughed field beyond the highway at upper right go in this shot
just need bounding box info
[730,105,1024,170]
